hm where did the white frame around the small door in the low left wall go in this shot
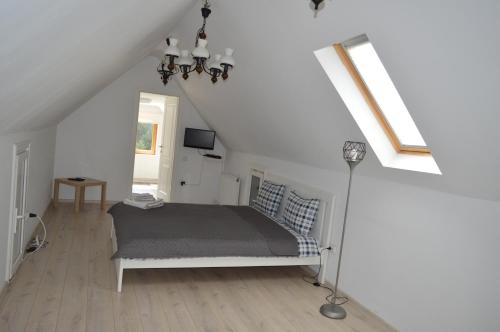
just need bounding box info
[5,141,31,282]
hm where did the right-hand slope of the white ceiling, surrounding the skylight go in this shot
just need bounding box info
[171,0,500,200]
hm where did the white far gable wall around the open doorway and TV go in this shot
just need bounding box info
[54,57,225,203]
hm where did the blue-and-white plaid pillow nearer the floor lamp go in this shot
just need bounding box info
[283,191,319,235]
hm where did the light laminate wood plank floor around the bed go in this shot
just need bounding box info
[0,204,392,332]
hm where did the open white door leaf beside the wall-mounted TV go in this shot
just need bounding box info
[158,96,179,202]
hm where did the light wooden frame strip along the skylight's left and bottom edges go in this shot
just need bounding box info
[333,39,431,155]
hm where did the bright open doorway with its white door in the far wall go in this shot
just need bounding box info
[132,92,179,202]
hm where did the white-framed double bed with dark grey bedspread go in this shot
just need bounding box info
[109,173,334,292]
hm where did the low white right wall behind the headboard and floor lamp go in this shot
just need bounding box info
[226,152,500,332]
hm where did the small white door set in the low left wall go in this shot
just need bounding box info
[8,143,29,279]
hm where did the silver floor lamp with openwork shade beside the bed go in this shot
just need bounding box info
[319,141,366,319]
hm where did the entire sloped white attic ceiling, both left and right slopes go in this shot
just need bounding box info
[0,0,500,201]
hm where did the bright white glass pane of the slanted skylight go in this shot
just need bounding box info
[342,35,427,147]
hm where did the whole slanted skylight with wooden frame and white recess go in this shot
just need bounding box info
[314,35,441,174]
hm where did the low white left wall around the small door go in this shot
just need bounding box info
[0,127,56,289]
